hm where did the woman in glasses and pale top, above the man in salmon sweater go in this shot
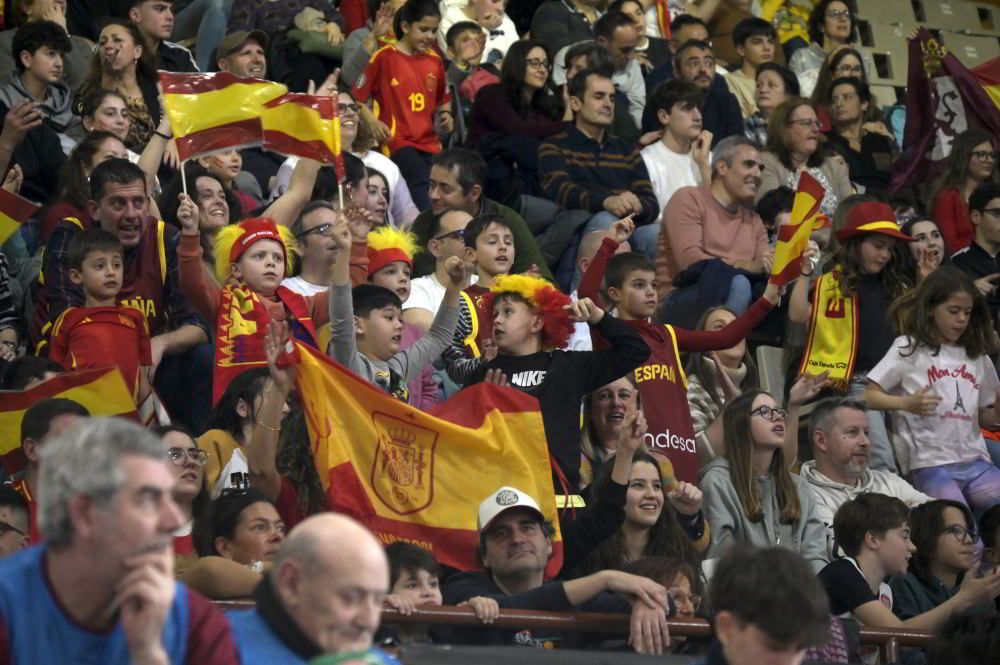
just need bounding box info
[756,97,853,217]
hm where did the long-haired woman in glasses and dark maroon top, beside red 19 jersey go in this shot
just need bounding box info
[466,40,573,204]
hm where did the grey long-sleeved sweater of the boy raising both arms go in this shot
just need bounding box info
[330,284,458,394]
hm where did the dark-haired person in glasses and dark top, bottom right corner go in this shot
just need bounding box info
[889,499,993,621]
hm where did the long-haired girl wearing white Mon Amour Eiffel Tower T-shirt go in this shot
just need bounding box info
[865,266,1000,511]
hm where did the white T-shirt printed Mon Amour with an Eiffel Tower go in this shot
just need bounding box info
[868,337,1000,473]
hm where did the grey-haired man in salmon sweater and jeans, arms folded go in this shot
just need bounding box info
[656,135,774,328]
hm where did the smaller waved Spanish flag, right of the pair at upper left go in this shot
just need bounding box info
[260,92,340,164]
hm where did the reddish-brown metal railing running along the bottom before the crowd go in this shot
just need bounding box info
[216,600,932,665]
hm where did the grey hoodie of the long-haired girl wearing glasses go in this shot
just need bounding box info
[699,458,828,573]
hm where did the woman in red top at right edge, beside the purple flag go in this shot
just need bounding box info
[931,129,998,256]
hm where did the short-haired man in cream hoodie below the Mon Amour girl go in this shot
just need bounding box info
[800,397,933,561]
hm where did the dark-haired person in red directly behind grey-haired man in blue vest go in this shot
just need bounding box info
[10,397,90,544]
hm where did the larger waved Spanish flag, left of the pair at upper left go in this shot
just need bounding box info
[160,72,288,160]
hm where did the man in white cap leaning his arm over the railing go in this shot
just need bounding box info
[444,487,671,654]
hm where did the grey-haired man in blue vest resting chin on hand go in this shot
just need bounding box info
[0,418,238,665]
